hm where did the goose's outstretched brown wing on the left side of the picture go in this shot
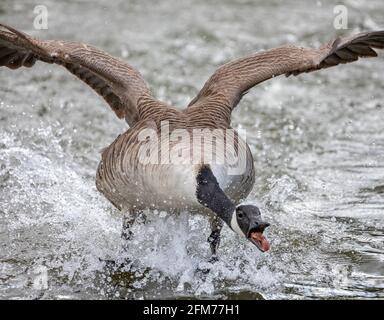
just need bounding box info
[0,24,150,125]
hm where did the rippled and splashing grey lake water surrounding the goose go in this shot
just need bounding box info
[0,0,384,299]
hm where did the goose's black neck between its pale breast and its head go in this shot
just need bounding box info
[196,165,236,226]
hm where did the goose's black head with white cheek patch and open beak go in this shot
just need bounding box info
[229,205,270,252]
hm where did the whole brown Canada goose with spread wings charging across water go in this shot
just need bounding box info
[0,25,384,256]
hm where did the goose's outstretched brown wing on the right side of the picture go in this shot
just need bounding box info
[189,31,384,121]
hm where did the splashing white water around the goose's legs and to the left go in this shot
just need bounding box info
[0,128,276,296]
